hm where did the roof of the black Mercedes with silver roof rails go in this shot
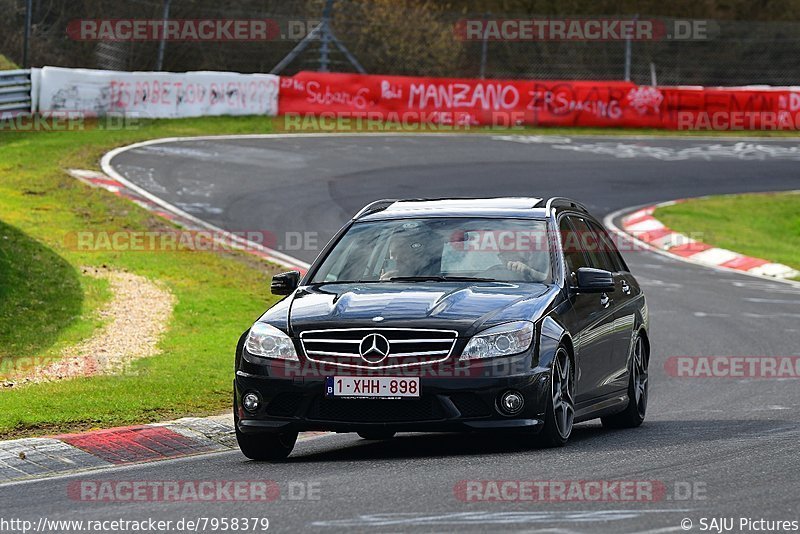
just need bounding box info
[353,197,586,221]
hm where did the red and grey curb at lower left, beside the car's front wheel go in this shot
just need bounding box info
[0,415,327,484]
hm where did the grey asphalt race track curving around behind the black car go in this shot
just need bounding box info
[0,135,800,532]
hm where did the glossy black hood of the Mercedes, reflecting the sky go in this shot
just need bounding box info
[289,282,557,336]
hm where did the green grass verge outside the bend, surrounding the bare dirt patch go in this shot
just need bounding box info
[0,116,798,439]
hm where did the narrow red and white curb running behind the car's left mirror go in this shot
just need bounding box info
[67,169,309,273]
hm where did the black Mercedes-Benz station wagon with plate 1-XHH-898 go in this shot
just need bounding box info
[233,198,650,460]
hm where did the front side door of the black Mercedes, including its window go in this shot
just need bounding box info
[559,214,616,406]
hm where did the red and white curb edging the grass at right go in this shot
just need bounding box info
[621,200,800,279]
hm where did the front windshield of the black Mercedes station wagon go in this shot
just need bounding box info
[311,217,551,283]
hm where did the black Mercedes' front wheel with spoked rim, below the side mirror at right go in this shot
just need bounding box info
[537,345,575,448]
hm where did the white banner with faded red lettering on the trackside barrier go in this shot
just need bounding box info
[38,67,279,118]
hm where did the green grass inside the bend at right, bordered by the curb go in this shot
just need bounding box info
[656,192,800,276]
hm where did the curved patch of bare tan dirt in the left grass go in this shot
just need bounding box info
[3,268,175,387]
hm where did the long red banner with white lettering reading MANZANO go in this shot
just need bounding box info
[279,72,800,130]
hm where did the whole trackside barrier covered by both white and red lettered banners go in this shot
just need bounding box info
[14,67,800,130]
